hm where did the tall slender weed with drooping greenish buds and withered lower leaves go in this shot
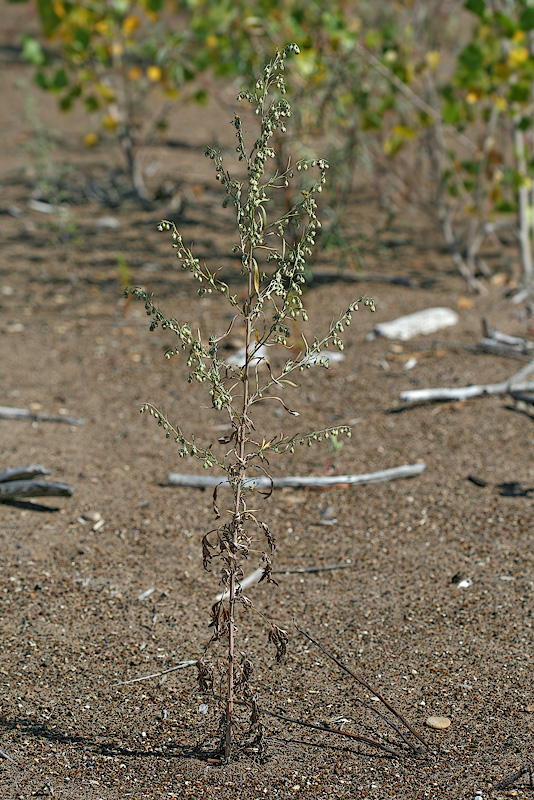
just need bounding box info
[126,44,374,762]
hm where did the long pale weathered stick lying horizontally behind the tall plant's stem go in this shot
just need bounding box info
[168,462,430,489]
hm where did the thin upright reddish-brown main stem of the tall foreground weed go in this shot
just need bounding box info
[224,264,254,763]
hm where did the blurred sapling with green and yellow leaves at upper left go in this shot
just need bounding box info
[16,0,205,201]
